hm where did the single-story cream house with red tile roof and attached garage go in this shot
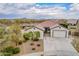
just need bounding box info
[23,21,69,39]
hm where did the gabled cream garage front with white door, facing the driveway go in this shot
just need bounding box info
[51,26,68,38]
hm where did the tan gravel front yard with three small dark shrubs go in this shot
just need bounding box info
[16,40,44,56]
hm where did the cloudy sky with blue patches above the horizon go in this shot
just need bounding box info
[0,3,79,19]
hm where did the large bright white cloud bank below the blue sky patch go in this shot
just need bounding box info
[23,6,79,19]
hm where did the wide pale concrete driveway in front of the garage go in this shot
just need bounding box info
[44,37,78,56]
